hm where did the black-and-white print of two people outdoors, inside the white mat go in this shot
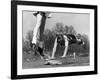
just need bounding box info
[22,11,90,69]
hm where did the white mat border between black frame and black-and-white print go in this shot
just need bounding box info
[17,5,94,75]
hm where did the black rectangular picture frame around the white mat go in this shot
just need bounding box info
[11,1,97,79]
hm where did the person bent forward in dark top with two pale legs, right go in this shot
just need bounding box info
[51,33,84,59]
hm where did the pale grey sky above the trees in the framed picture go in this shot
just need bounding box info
[23,11,90,38]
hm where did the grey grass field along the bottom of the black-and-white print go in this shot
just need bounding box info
[22,53,89,69]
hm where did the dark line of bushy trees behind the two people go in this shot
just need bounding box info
[23,23,90,55]
